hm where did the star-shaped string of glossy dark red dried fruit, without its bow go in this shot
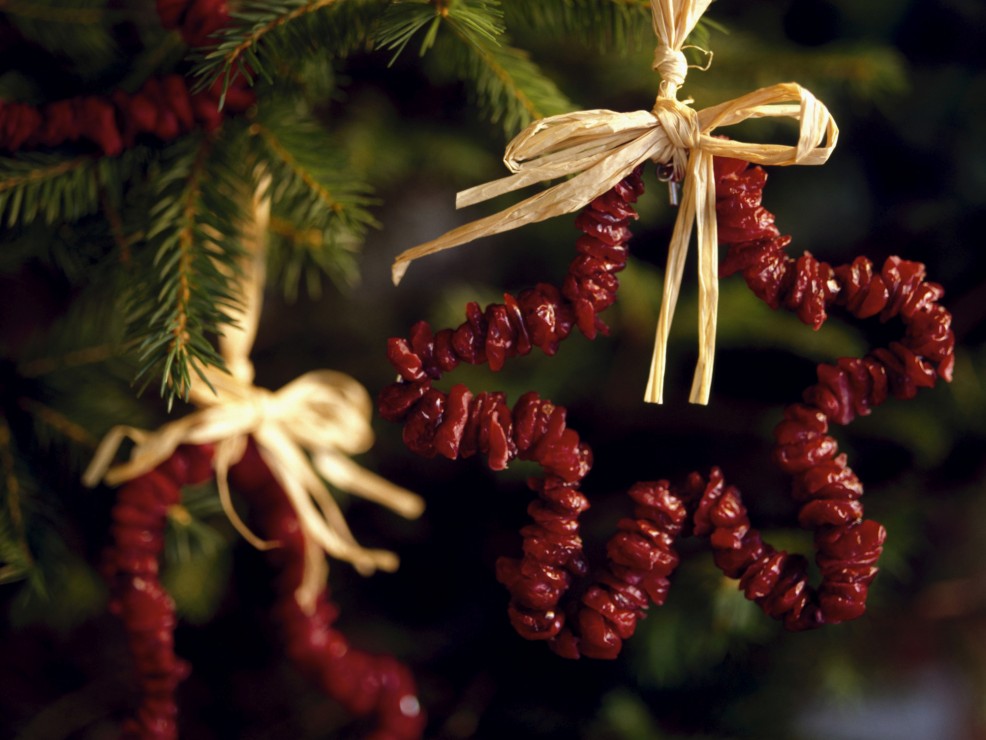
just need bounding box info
[379,160,954,658]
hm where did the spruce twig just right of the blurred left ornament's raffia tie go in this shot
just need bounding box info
[250,107,377,299]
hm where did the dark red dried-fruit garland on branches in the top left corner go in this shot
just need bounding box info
[0,0,254,156]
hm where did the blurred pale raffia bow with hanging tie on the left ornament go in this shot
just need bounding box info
[83,176,424,607]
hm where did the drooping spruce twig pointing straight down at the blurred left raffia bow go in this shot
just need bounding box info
[127,136,249,408]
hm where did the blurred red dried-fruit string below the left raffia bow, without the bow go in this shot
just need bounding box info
[104,444,425,740]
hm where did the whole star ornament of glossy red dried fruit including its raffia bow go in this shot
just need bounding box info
[378,0,954,658]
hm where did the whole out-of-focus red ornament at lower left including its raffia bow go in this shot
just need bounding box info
[83,178,423,738]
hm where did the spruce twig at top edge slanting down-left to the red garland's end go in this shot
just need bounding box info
[194,0,387,107]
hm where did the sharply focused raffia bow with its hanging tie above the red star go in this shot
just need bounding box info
[393,0,839,404]
